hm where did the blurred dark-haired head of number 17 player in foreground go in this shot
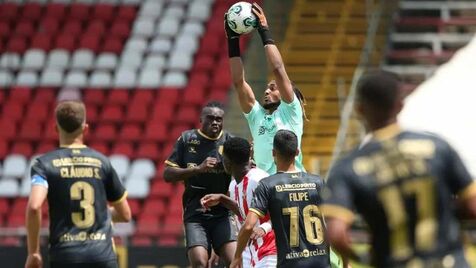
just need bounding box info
[356,71,403,130]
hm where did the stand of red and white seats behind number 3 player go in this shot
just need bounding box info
[0,0,255,246]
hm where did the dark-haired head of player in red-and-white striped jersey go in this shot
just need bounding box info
[223,137,251,174]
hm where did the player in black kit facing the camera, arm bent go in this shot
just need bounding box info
[164,102,237,267]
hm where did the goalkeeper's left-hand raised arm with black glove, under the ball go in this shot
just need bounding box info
[224,14,256,113]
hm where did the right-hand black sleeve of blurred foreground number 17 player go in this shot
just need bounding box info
[443,141,476,198]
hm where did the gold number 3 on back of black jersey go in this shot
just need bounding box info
[70,181,95,229]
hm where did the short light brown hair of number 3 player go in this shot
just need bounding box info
[55,100,86,133]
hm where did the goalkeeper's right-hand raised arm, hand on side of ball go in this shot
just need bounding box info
[252,3,294,103]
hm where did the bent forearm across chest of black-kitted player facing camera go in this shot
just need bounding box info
[164,157,218,182]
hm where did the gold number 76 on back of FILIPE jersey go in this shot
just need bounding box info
[283,205,324,247]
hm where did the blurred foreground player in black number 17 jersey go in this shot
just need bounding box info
[322,72,476,268]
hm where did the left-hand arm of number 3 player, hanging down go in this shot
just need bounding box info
[25,185,48,268]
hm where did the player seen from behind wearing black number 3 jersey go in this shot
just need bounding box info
[25,101,131,268]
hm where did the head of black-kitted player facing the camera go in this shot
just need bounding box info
[200,101,225,138]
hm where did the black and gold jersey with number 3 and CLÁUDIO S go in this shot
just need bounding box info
[31,146,126,263]
